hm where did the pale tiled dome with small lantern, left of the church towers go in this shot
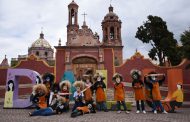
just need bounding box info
[31,33,51,48]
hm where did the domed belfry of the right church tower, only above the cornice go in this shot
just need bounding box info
[102,5,122,46]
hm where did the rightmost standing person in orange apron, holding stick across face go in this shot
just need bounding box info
[145,72,167,114]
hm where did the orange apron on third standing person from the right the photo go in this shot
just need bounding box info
[114,83,125,101]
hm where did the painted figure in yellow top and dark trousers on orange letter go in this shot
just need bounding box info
[169,83,183,113]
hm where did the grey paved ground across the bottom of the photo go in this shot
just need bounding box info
[0,105,190,122]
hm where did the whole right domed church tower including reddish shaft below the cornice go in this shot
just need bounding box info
[102,5,123,66]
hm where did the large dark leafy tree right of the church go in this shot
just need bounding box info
[135,15,181,66]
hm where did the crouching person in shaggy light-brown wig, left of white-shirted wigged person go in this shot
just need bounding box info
[59,80,71,110]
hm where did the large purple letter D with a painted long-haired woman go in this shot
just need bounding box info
[4,69,42,108]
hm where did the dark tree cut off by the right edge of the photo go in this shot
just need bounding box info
[180,28,190,59]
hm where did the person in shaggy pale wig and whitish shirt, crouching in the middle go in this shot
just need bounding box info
[72,81,85,112]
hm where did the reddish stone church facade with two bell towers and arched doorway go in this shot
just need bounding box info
[55,1,123,80]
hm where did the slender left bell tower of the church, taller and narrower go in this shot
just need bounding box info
[66,0,79,45]
